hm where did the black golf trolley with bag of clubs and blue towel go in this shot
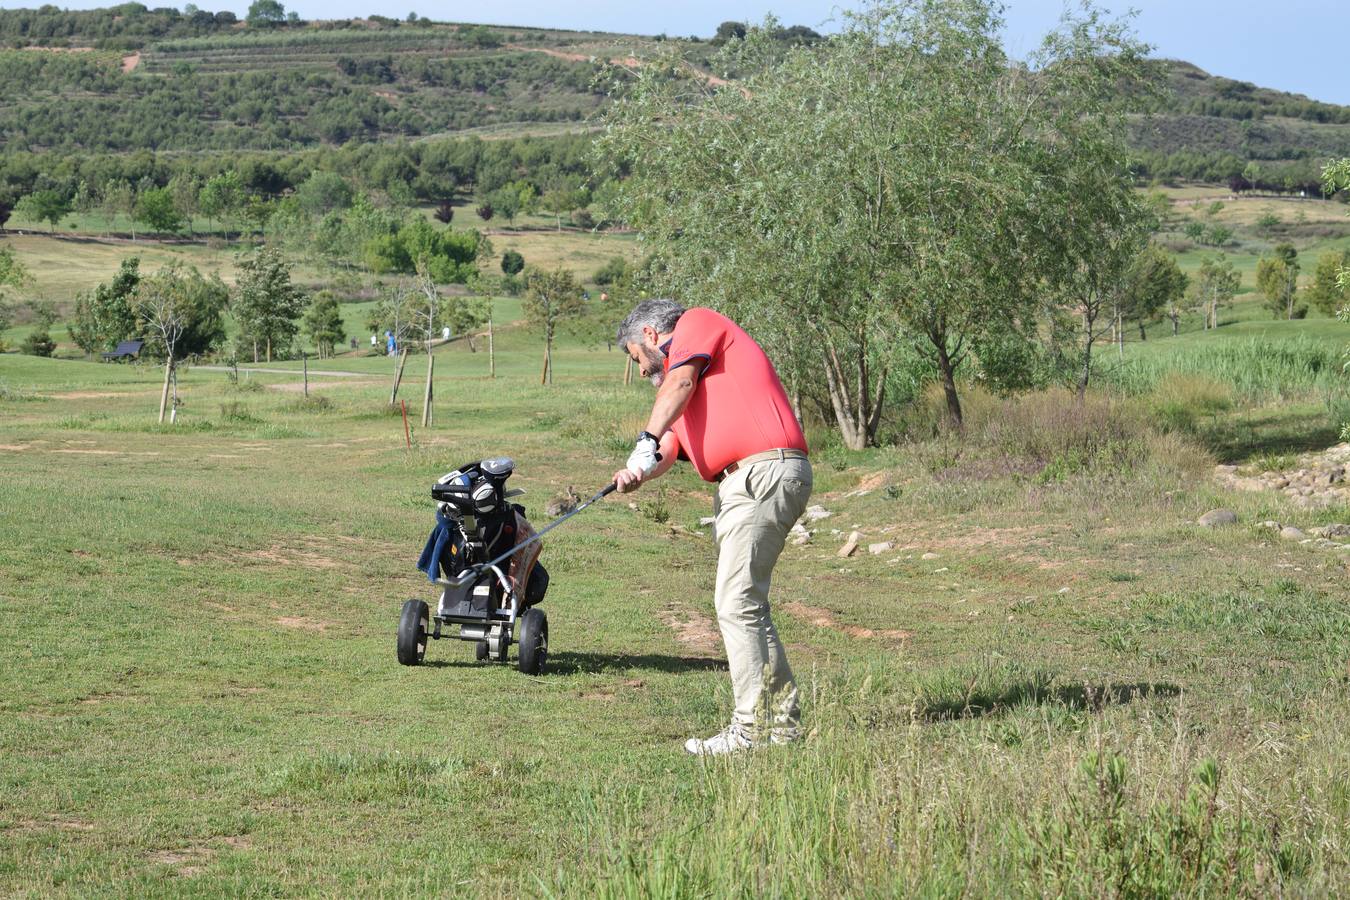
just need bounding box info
[398,456,548,675]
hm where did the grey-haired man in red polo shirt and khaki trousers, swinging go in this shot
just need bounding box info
[614,300,811,756]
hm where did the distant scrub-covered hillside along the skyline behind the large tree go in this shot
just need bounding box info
[0,4,1350,186]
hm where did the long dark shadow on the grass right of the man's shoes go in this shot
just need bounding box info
[919,676,1181,722]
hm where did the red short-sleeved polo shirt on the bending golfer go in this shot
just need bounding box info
[664,308,806,482]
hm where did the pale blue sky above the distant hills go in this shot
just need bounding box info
[0,0,1350,105]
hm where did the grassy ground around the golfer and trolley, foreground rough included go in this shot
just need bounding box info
[0,307,1350,897]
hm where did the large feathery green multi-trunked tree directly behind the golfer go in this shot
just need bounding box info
[598,0,1152,448]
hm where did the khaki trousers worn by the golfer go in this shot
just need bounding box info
[713,459,811,733]
